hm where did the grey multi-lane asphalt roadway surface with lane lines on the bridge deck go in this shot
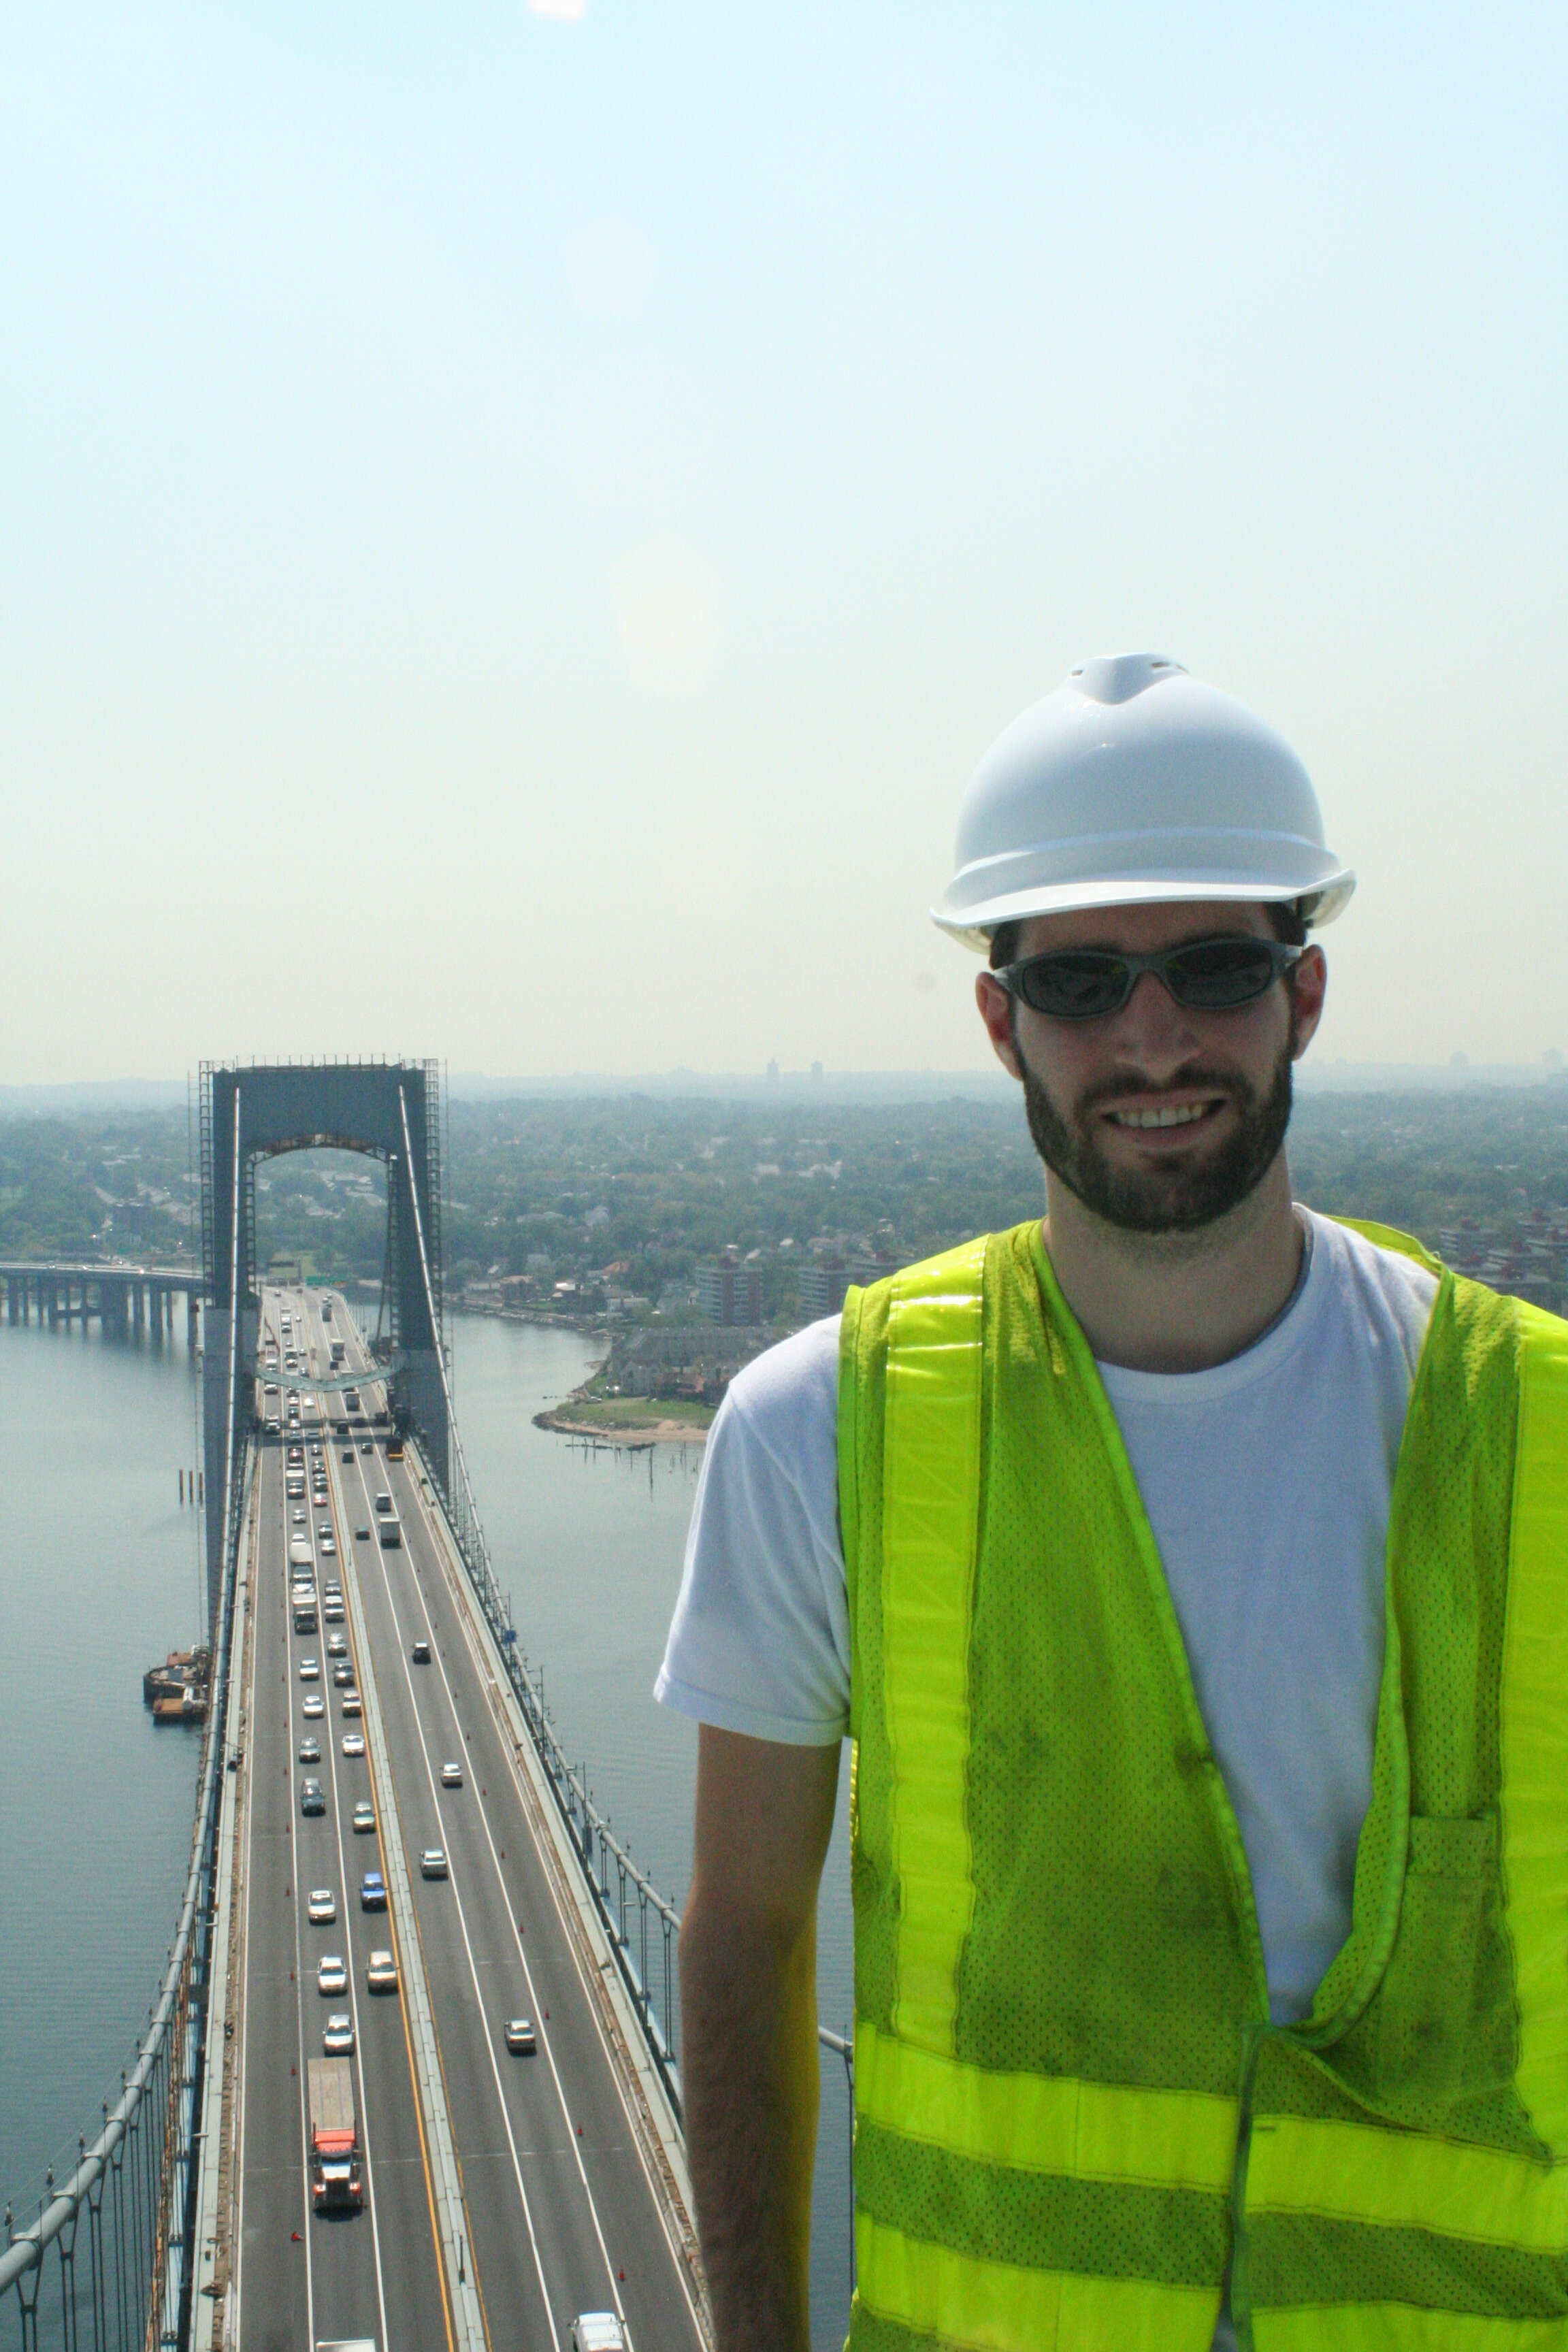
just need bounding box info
[231,1289,703,2352]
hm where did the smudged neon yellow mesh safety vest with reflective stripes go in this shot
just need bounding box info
[839,1226,1568,2352]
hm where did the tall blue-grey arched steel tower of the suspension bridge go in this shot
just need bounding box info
[200,1061,449,1609]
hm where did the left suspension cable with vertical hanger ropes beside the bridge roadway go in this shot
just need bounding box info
[0,1091,244,2352]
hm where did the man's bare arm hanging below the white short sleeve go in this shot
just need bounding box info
[679,1724,839,2352]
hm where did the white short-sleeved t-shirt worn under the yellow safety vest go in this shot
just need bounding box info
[656,1209,1437,2352]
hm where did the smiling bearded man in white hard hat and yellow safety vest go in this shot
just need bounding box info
[661,656,1568,2352]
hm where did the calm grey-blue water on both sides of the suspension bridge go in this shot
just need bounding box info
[0,1317,851,2347]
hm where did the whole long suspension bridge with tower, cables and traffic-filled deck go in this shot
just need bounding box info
[0,1061,847,2352]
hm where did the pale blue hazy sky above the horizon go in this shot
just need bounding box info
[0,0,1568,1082]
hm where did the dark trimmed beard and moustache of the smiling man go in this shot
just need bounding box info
[1018,1023,1295,1232]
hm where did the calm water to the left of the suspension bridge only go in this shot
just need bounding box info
[0,1315,205,2223]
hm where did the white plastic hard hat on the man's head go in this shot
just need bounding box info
[931,654,1356,953]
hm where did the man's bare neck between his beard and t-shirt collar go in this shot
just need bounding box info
[1044,1152,1303,1371]
